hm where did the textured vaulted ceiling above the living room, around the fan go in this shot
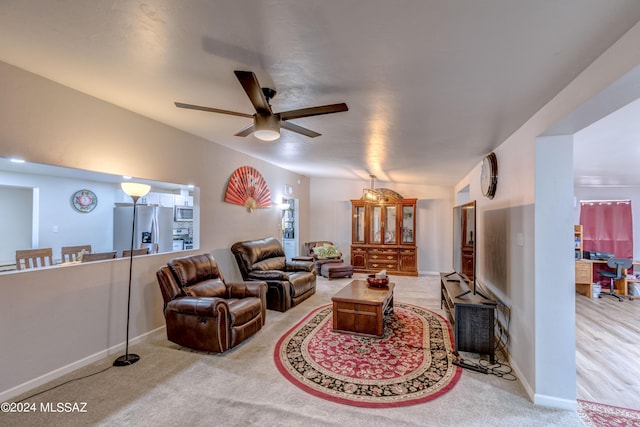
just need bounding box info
[0,0,640,185]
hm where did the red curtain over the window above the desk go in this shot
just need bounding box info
[580,200,633,258]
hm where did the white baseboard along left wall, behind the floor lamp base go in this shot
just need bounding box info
[0,326,166,402]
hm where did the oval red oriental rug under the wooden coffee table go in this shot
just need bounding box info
[274,303,461,408]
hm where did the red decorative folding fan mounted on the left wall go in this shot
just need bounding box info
[224,166,271,212]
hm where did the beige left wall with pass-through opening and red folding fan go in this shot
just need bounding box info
[0,63,309,401]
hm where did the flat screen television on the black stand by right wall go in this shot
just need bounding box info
[451,200,486,298]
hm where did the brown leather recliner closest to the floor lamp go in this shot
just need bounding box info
[156,254,267,353]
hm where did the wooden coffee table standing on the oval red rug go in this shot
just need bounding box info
[331,280,395,337]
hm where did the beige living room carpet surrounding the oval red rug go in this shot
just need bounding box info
[0,276,583,427]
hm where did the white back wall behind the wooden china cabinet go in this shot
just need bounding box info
[308,178,453,274]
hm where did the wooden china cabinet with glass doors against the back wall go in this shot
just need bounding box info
[351,188,418,276]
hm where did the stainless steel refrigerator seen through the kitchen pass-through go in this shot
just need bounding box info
[113,203,173,256]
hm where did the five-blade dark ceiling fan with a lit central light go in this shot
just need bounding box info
[175,71,349,141]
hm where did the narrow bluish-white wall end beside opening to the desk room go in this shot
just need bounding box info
[534,135,576,405]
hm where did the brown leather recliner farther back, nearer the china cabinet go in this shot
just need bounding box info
[231,237,316,311]
